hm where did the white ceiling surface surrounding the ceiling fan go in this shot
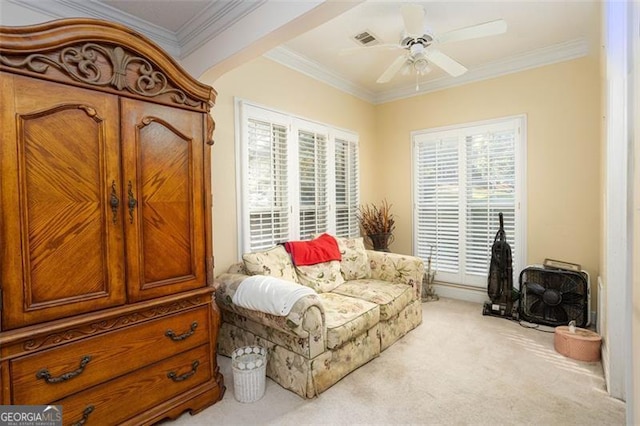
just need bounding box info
[274,0,600,102]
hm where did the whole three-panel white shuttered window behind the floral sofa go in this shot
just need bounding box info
[237,101,360,253]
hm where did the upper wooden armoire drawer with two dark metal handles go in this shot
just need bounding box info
[10,306,210,405]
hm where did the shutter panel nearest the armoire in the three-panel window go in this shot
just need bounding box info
[245,119,289,251]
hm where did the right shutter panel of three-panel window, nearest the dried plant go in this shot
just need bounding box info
[335,137,360,237]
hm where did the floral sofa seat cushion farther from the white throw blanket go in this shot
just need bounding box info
[332,279,413,321]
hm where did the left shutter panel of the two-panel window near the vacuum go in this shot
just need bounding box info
[415,137,460,274]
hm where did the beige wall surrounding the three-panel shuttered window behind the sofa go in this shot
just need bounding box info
[200,58,375,275]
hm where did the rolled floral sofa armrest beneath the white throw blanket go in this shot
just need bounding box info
[216,273,326,340]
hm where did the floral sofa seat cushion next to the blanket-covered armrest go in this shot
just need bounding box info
[318,293,380,349]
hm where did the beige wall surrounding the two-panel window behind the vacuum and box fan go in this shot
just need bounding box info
[376,57,601,282]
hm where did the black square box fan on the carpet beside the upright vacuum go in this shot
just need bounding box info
[519,266,589,327]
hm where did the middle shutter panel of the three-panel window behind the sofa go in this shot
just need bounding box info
[298,130,329,240]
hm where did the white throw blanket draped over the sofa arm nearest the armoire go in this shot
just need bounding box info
[231,275,316,316]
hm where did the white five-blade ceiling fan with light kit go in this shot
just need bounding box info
[341,4,507,83]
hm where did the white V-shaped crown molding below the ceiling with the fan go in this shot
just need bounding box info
[264,38,589,105]
